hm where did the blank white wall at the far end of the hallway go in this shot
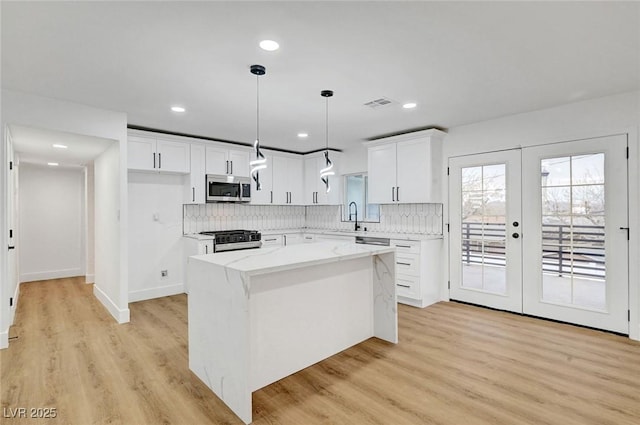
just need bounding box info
[18,162,85,282]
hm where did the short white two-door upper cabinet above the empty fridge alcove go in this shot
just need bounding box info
[127,136,190,174]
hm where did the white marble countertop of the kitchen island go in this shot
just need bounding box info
[191,242,395,276]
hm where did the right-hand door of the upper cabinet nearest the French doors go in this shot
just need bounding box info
[396,139,432,204]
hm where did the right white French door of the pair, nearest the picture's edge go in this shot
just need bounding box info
[523,135,629,333]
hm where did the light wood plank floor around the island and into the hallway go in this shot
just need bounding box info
[0,279,640,425]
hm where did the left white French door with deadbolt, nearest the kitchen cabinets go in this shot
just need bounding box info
[449,149,522,312]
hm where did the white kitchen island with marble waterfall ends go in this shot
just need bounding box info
[187,242,398,424]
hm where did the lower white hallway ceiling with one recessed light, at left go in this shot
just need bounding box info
[9,125,114,167]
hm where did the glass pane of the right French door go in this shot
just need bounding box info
[540,153,606,310]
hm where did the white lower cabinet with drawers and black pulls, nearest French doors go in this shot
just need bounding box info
[391,239,443,307]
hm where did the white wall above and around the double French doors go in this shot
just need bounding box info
[443,91,640,339]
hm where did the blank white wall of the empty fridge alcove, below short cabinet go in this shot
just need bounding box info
[129,172,185,302]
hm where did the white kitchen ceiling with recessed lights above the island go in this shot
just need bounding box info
[0,1,640,151]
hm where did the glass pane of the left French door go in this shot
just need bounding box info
[461,164,507,294]
